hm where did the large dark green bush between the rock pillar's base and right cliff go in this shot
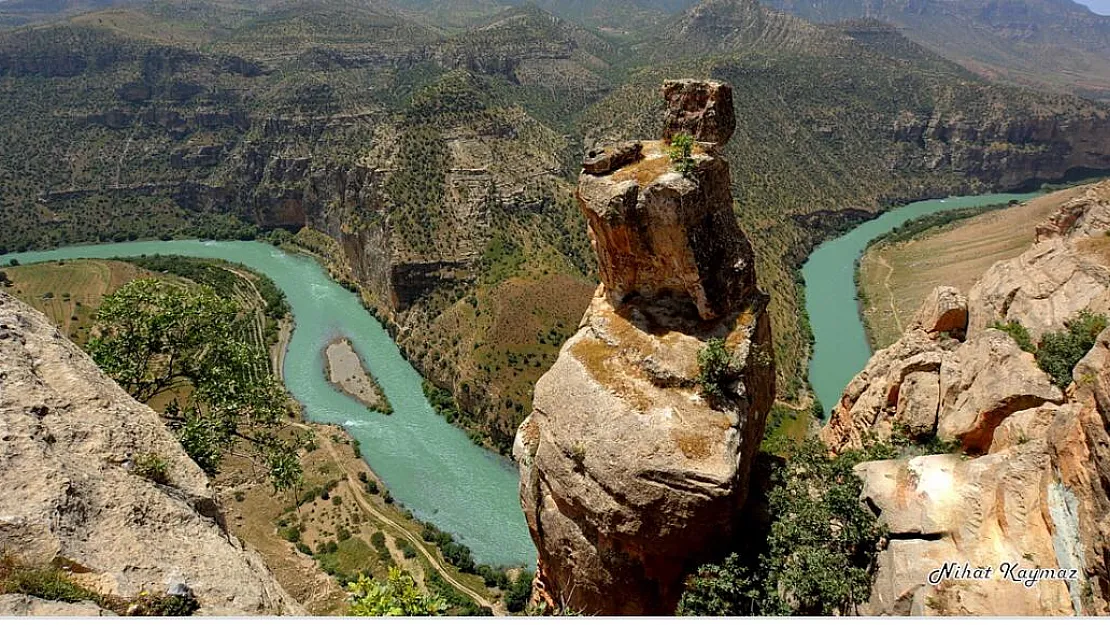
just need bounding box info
[678,438,894,616]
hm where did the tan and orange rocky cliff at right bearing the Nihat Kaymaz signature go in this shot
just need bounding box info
[821,182,1110,615]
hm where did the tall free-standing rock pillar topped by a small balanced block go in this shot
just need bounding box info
[514,81,775,614]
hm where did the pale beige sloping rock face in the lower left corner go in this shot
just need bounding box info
[0,293,303,615]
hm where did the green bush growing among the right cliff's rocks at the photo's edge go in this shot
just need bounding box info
[991,310,1107,390]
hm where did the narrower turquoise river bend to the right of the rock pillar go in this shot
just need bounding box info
[801,193,1040,416]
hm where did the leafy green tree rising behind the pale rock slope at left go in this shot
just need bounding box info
[88,280,301,490]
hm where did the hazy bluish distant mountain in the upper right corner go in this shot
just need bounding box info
[766,0,1110,99]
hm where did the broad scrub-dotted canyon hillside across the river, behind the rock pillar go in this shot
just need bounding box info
[0,0,1110,451]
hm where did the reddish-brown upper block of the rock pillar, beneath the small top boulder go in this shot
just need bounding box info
[578,141,755,319]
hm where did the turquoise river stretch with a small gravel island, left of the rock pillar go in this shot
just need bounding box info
[0,241,536,565]
